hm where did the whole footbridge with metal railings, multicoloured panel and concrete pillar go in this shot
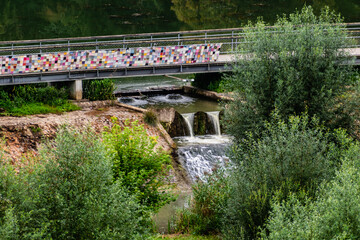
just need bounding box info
[0,23,360,99]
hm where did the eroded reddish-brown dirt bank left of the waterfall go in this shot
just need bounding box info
[0,101,188,188]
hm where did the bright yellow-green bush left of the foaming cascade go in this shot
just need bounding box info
[104,118,172,210]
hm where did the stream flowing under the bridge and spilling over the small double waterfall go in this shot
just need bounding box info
[116,76,231,233]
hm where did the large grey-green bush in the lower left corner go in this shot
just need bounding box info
[0,128,148,239]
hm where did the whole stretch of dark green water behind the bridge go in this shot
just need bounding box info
[0,0,360,40]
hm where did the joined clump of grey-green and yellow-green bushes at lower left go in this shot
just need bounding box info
[0,120,173,239]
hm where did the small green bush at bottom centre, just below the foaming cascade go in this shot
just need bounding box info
[173,169,229,234]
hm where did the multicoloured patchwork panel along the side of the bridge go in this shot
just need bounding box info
[0,44,221,74]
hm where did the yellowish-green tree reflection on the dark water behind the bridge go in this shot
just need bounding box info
[171,0,360,29]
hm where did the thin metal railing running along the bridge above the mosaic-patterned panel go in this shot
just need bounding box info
[0,23,360,55]
